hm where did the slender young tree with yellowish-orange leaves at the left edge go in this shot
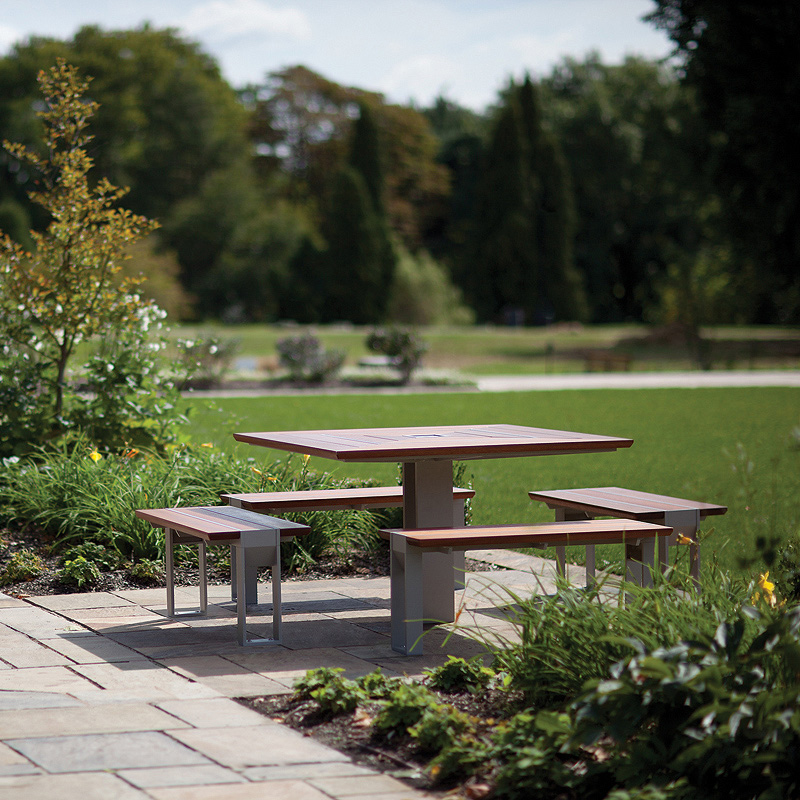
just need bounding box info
[0,59,169,454]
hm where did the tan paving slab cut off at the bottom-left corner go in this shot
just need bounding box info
[0,772,147,800]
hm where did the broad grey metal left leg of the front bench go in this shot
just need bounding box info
[390,535,423,656]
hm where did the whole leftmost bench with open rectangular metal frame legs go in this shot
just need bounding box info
[136,506,311,646]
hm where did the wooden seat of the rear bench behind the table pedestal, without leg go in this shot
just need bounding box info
[220,486,475,511]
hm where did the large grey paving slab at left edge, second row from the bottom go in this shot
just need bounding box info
[6,731,211,774]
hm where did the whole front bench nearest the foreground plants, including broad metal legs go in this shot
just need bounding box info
[386,520,672,655]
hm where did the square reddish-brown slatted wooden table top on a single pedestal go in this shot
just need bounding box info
[233,425,633,461]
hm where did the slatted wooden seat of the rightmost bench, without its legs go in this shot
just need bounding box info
[528,486,728,520]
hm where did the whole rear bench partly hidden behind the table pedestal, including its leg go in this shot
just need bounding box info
[220,486,475,589]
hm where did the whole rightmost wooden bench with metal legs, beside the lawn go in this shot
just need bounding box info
[528,486,728,586]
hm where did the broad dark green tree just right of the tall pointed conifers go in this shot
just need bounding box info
[540,54,714,322]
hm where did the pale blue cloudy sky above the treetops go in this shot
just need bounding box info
[0,0,671,111]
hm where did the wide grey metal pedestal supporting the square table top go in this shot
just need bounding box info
[403,461,455,622]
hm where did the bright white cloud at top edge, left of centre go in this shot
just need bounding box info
[178,0,311,40]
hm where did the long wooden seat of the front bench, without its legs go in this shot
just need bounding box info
[386,520,672,550]
